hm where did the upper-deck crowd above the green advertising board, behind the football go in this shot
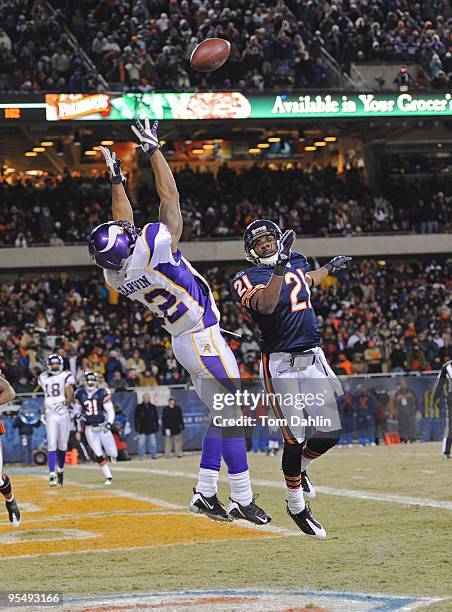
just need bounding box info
[0,0,452,92]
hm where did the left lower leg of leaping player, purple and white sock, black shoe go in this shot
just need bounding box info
[189,423,232,522]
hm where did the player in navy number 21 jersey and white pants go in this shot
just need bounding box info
[231,219,351,539]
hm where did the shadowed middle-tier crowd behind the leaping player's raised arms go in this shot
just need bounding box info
[0,164,452,247]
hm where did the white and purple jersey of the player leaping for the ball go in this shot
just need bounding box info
[104,223,220,336]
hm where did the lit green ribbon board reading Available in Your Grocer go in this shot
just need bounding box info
[46,91,452,121]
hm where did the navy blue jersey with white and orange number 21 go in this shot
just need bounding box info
[231,253,320,353]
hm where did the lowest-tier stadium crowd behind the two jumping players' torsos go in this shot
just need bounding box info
[0,259,452,392]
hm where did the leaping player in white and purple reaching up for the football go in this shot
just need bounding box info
[89,120,271,524]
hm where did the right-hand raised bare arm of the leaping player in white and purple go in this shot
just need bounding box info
[151,150,183,251]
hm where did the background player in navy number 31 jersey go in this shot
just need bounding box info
[74,372,118,485]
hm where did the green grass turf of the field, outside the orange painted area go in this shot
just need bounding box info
[2,443,452,611]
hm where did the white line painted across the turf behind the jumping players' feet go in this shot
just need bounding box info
[74,465,452,510]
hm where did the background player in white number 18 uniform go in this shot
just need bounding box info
[38,354,75,487]
